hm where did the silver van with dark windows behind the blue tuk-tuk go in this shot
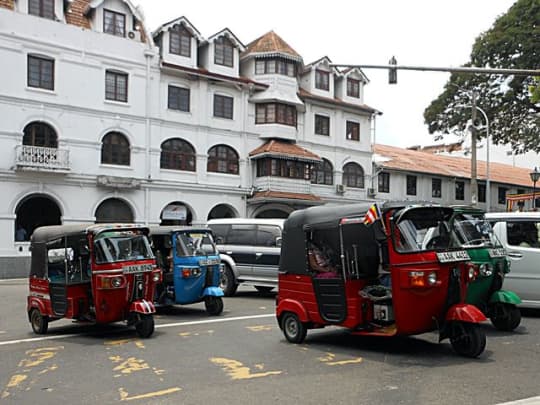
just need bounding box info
[208,218,285,296]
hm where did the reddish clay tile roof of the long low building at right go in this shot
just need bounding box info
[373,145,531,187]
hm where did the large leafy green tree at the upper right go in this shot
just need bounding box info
[424,0,540,152]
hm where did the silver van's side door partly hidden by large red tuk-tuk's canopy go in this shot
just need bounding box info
[253,224,281,283]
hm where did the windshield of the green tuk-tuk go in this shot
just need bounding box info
[452,214,501,247]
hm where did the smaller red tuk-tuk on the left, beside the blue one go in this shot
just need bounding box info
[27,224,161,337]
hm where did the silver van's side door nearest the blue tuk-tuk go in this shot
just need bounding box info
[224,224,257,278]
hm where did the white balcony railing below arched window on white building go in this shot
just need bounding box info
[15,145,70,171]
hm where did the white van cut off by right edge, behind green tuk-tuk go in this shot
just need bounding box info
[486,212,540,308]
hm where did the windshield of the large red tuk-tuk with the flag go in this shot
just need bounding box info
[393,207,451,253]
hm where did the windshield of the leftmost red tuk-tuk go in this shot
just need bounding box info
[95,231,154,264]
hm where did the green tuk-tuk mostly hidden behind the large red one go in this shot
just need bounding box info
[450,206,521,331]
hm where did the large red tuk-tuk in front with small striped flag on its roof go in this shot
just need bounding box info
[276,202,486,357]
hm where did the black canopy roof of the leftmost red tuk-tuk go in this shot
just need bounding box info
[30,223,148,243]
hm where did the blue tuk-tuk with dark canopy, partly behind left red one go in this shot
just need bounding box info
[150,226,224,315]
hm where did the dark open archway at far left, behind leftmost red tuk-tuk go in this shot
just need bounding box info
[15,195,62,241]
